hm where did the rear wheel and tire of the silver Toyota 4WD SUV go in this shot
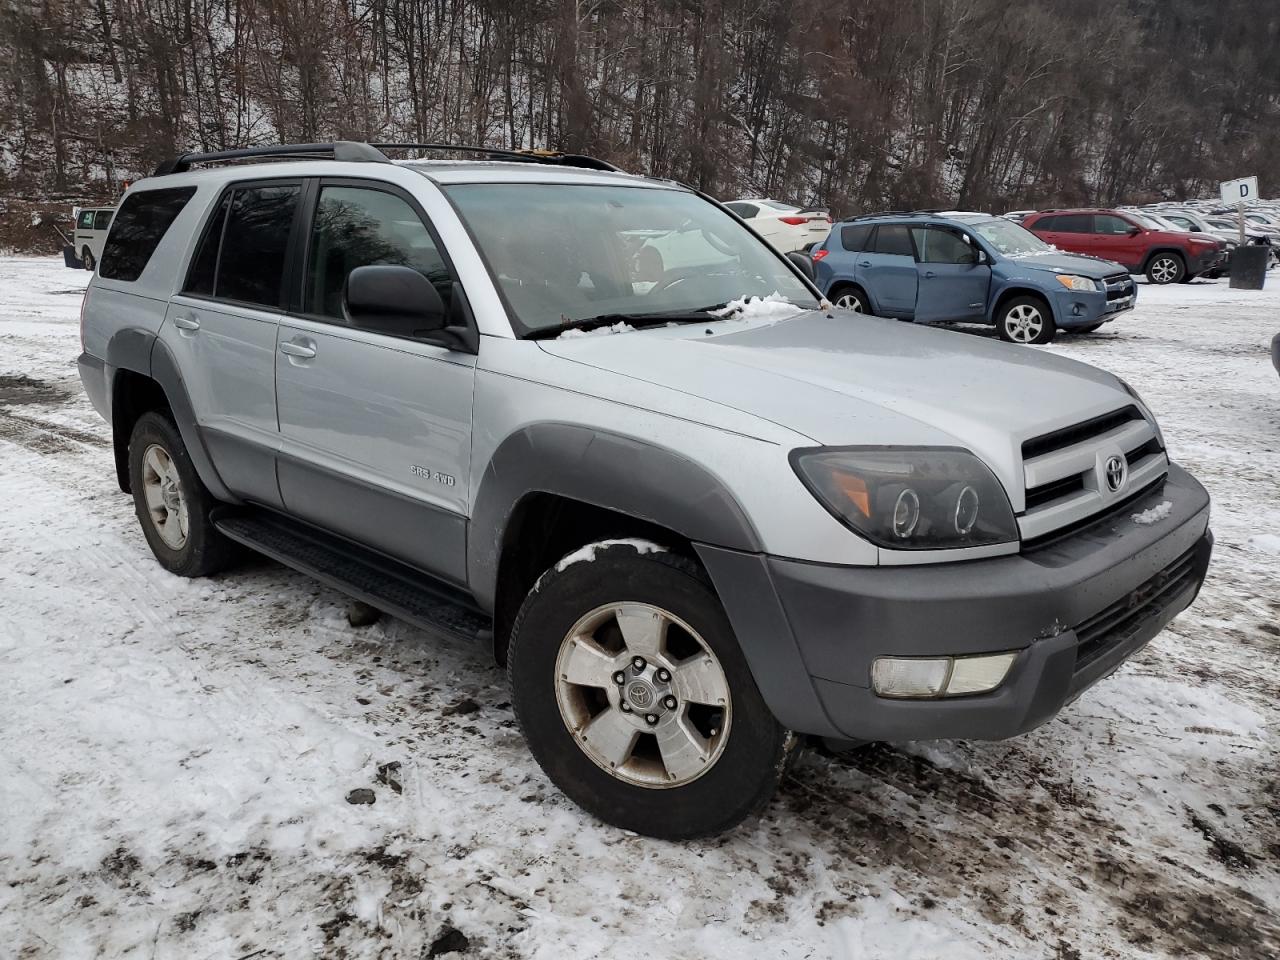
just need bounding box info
[129,411,236,577]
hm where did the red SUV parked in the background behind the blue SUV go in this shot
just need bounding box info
[1023,210,1226,283]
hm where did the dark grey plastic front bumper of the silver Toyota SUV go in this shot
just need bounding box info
[699,465,1213,740]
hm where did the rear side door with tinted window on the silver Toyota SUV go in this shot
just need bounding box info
[161,179,302,507]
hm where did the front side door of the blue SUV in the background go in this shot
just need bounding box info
[911,227,991,324]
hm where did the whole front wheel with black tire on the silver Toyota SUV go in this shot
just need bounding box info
[507,541,799,840]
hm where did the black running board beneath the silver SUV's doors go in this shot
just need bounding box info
[214,509,493,640]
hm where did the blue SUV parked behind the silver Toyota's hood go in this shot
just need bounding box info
[813,211,1138,343]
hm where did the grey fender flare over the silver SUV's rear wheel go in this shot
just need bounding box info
[106,326,238,503]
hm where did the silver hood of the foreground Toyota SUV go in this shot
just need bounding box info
[540,310,1133,493]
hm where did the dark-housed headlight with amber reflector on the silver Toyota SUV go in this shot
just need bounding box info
[791,447,1018,550]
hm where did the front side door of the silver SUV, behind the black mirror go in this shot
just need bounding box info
[275,179,476,584]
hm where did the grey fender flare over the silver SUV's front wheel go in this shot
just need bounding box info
[467,422,763,609]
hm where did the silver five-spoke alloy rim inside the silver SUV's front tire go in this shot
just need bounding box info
[556,603,732,788]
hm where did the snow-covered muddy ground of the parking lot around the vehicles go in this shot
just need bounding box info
[0,259,1280,960]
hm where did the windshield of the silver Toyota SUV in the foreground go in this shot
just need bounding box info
[444,183,818,334]
